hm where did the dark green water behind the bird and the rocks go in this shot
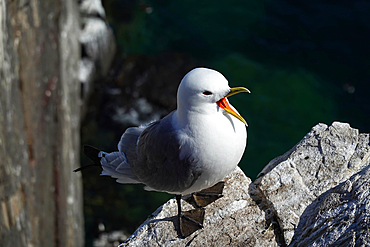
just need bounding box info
[85,0,370,242]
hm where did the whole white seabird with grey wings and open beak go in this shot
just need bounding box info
[76,68,249,236]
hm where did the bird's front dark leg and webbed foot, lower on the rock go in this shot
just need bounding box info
[176,195,204,238]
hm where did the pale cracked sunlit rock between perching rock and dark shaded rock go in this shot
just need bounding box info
[255,122,369,244]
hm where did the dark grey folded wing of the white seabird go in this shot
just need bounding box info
[128,113,200,193]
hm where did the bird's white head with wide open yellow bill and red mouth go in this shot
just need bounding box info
[177,68,250,126]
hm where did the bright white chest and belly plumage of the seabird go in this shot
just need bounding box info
[176,113,247,194]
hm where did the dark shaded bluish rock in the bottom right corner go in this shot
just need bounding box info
[290,163,370,247]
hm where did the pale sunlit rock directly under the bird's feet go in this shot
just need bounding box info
[120,168,278,247]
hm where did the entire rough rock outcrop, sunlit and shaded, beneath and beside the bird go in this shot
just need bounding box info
[120,122,370,246]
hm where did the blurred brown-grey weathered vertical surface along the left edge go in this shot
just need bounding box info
[0,0,83,246]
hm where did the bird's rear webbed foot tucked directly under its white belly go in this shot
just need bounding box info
[187,182,225,207]
